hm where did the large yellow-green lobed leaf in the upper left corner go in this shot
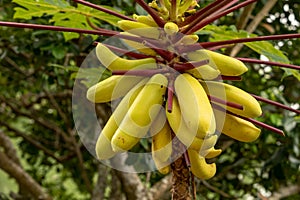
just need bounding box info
[13,0,120,40]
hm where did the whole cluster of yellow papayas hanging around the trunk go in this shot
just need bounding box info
[87,1,262,179]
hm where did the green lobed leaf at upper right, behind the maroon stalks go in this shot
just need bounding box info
[197,25,300,81]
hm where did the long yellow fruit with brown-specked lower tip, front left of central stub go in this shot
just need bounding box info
[112,74,168,152]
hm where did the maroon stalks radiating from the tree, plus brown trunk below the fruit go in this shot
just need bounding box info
[0,0,300,199]
